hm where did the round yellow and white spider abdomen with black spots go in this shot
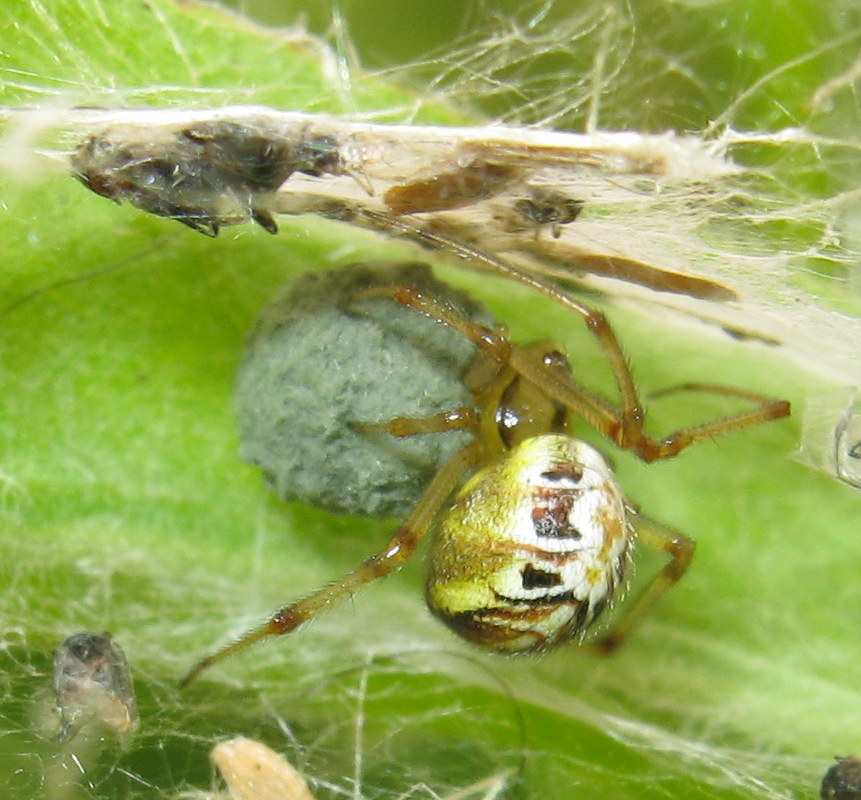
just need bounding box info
[427,434,629,653]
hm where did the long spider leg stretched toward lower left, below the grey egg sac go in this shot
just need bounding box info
[180,442,481,688]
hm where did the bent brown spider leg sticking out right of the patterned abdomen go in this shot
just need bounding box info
[593,512,696,653]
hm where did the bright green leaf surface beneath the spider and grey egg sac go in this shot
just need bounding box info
[0,0,861,800]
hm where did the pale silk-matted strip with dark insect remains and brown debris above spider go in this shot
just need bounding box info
[70,107,736,300]
